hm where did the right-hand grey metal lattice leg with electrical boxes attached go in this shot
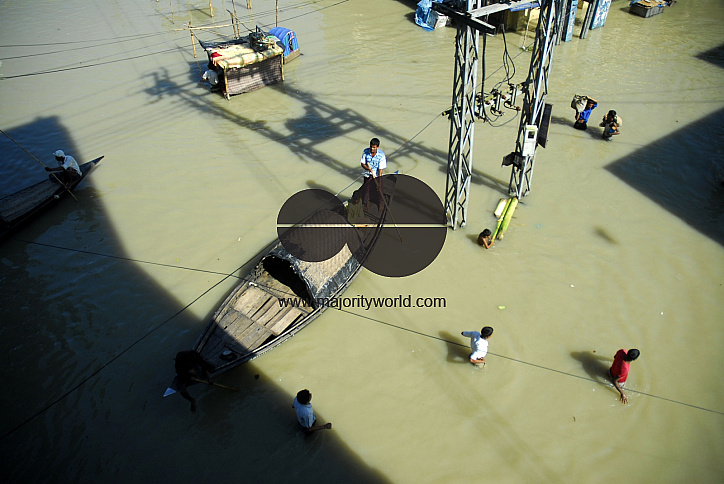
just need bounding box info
[508,0,563,199]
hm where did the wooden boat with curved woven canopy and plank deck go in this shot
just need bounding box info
[164,175,396,396]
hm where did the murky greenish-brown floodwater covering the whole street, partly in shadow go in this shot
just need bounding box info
[0,0,724,483]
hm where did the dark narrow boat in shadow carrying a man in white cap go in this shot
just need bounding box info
[0,156,103,240]
